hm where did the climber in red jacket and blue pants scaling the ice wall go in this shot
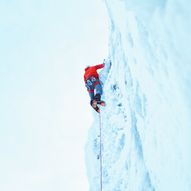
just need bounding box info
[84,63,105,113]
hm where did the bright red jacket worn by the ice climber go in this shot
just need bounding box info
[84,64,104,82]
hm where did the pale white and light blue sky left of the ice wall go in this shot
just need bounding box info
[0,0,108,191]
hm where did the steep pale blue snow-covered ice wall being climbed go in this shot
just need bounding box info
[86,0,191,191]
